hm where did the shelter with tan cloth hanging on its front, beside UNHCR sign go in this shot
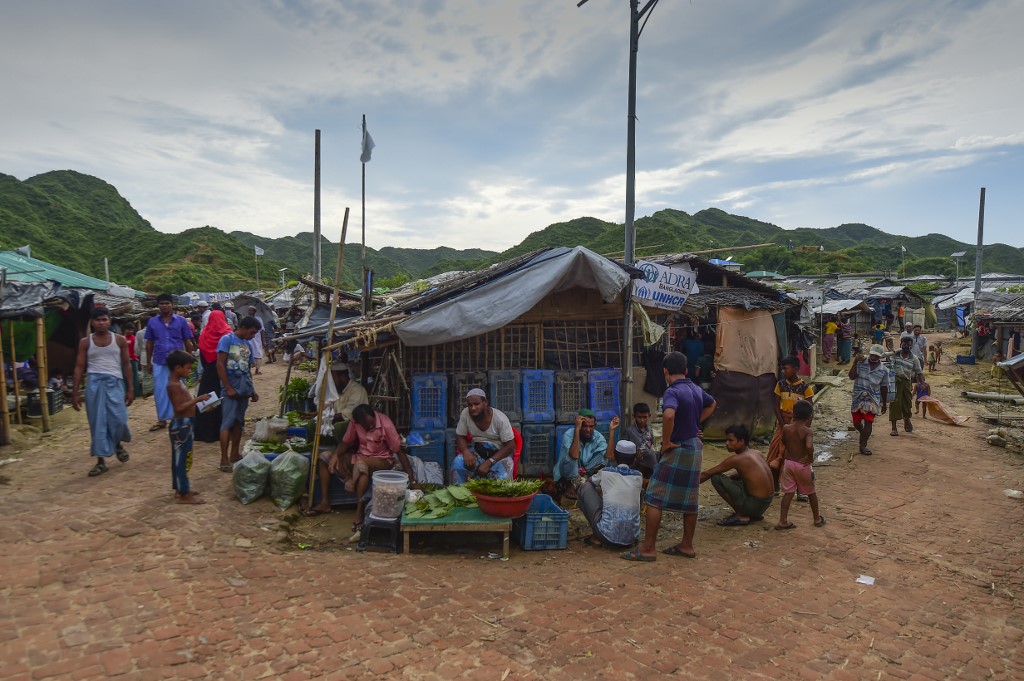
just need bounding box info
[654,254,814,439]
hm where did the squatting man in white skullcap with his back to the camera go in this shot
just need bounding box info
[577,439,643,548]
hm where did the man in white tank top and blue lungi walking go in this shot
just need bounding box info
[72,307,135,476]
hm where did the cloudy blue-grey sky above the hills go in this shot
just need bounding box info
[0,0,1024,250]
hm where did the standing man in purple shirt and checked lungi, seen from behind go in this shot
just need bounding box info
[622,352,717,562]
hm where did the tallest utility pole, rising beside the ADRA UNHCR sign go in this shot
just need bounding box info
[577,0,658,423]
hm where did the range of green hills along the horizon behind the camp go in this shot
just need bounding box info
[0,170,1024,293]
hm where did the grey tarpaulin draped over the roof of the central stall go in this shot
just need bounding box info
[396,246,631,346]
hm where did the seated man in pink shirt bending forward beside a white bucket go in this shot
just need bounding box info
[305,405,416,531]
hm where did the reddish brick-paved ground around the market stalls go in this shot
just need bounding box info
[0,358,1024,681]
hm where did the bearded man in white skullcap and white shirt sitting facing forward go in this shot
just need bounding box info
[450,388,515,484]
